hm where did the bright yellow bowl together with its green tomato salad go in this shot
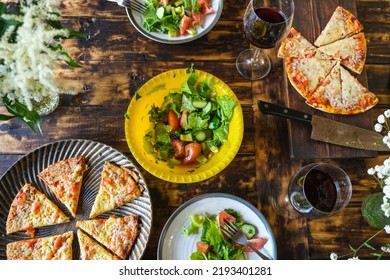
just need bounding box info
[125,68,244,183]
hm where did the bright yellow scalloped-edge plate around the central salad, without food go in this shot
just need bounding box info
[125,69,244,183]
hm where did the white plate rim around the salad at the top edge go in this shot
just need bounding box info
[126,0,223,44]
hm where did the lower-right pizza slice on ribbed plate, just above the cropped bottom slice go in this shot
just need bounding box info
[76,215,141,259]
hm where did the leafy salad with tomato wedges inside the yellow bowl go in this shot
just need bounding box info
[144,71,237,167]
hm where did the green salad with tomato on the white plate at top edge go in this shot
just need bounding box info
[142,0,214,37]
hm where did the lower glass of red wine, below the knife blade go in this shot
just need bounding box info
[288,163,352,219]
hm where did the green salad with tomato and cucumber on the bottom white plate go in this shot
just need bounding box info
[182,209,267,260]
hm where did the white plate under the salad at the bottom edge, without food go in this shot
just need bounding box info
[157,193,277,260]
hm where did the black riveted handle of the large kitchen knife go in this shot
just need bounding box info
[257,100,312,123]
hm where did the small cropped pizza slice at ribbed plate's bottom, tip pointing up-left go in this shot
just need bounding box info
[77,230,120,260]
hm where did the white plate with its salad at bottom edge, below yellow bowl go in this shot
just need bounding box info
[157,193,277,260]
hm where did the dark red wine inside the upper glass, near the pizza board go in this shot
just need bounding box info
[244,8,287,49]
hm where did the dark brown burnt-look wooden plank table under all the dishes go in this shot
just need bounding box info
[0,0,390,259]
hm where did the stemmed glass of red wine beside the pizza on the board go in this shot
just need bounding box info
[236,0,294,80]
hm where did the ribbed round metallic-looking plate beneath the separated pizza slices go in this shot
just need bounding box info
[0,140,152,260]
